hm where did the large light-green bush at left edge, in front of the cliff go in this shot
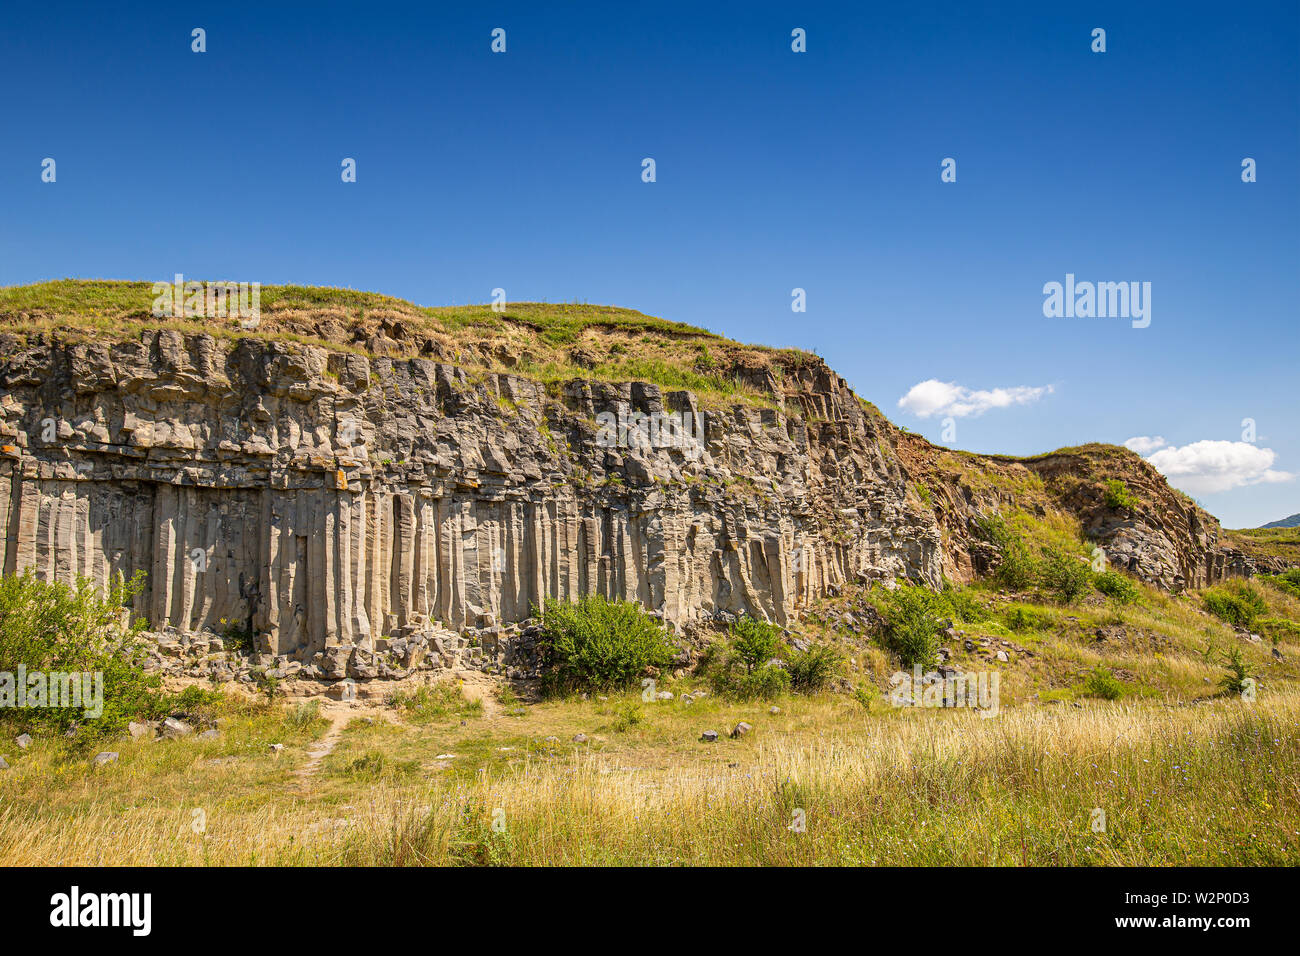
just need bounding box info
[0,571,169,741]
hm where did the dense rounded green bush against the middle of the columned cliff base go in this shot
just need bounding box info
[538,594,676,695]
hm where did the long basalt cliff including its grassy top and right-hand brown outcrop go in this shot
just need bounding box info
[0,282,1279,676]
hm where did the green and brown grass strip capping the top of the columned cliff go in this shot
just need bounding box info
[0,280,820,406]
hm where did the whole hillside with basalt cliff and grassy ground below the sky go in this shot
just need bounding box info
[0,282,1300,866]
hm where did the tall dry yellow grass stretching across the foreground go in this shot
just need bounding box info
[0,689,1300,865]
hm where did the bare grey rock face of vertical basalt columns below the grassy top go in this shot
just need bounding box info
[0,330,943,658]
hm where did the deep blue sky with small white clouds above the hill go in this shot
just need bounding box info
[0,3,1300,527]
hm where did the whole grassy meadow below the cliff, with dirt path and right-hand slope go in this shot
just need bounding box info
[0,567,1300,866]
